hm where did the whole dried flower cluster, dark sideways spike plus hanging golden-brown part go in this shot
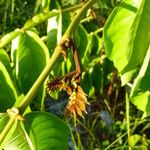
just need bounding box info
[47,75,89,126]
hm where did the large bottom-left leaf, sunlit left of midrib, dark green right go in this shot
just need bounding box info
[0,112,69,150]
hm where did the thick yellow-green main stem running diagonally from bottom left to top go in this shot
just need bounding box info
[0,0,96,144]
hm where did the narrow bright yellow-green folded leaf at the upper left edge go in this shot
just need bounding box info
[0,29,21,48]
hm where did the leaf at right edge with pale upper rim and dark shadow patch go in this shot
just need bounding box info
[130,48,150,115]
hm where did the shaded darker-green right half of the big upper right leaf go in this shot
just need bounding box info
[121,0,150,81]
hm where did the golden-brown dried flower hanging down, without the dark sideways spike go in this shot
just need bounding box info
[65,85,89,126]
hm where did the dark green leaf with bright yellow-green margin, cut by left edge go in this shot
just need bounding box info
[0,62,17,112]
